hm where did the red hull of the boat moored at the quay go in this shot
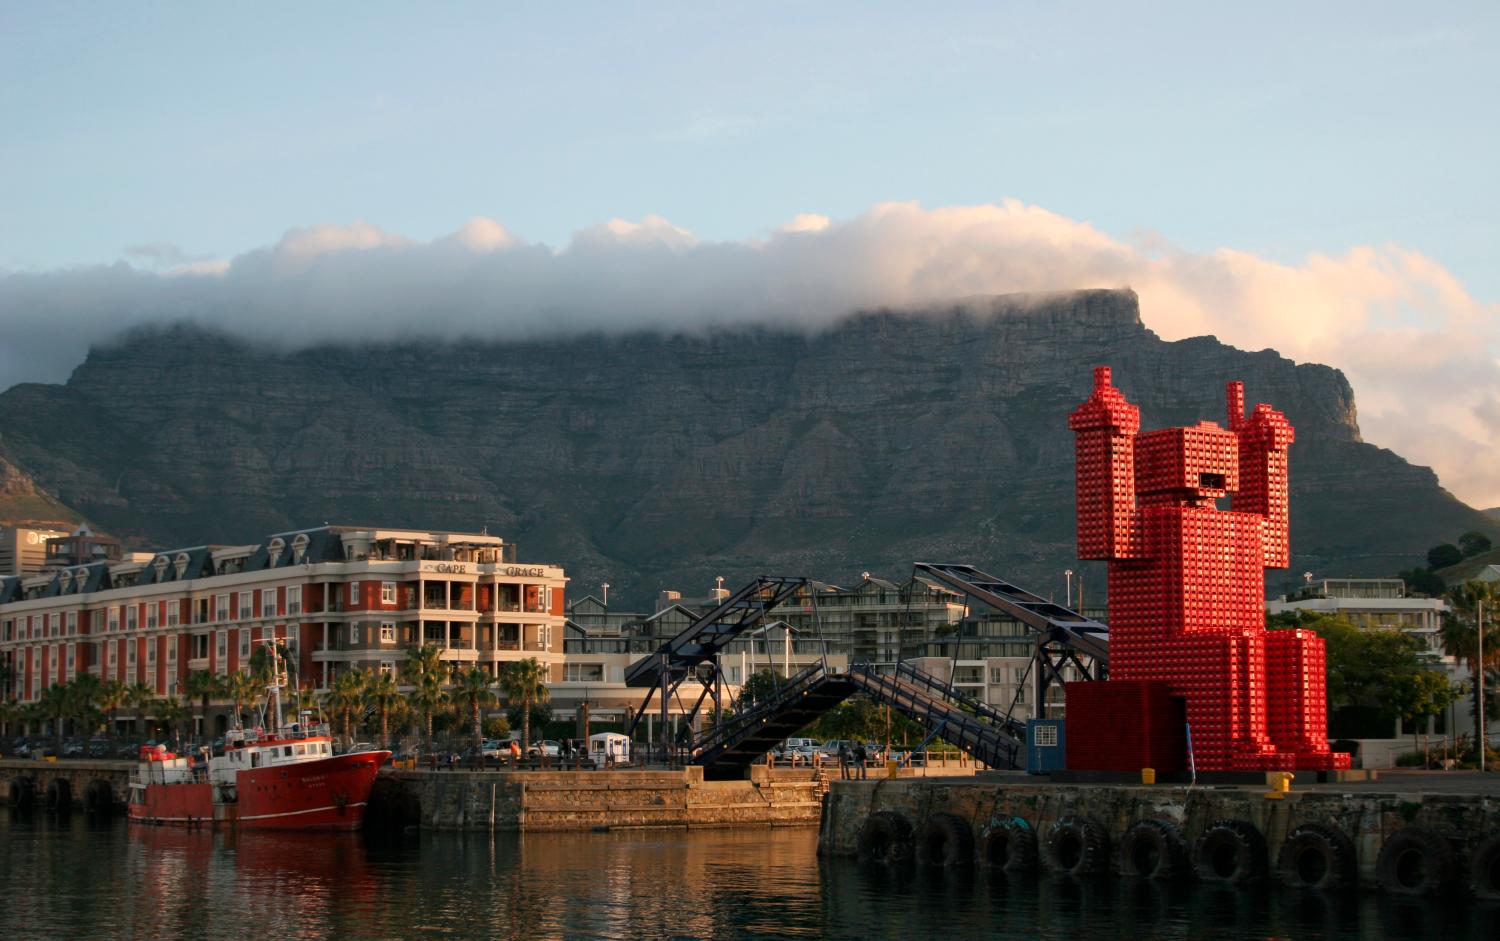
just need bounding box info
[129,752,390,830]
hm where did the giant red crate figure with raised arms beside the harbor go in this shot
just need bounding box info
[1068,366,1349,771]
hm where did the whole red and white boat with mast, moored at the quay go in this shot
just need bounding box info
[129,651,390,830]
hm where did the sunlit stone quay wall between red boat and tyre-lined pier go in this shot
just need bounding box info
[366,768,827,831]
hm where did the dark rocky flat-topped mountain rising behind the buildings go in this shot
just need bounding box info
[0,291,1496,600]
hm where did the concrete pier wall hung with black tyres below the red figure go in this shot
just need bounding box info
[819,773,1500,897]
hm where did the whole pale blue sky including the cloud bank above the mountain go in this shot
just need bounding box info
[0,0,1500,506]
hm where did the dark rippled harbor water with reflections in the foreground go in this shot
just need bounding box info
[0,813,1500,941]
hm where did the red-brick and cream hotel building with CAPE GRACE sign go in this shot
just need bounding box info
[0,525,567,714]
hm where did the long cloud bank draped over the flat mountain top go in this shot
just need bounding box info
[0,200,1500,506]
